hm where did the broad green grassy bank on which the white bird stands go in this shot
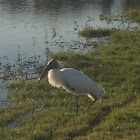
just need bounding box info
[0,9,140,140]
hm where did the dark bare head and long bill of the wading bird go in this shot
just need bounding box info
[38,59,58,82]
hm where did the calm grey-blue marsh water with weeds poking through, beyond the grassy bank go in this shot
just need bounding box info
[0,0,140,107]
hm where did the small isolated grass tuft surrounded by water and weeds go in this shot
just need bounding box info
[79,27,114,38]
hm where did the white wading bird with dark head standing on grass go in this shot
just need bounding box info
[38,59,105,114]
